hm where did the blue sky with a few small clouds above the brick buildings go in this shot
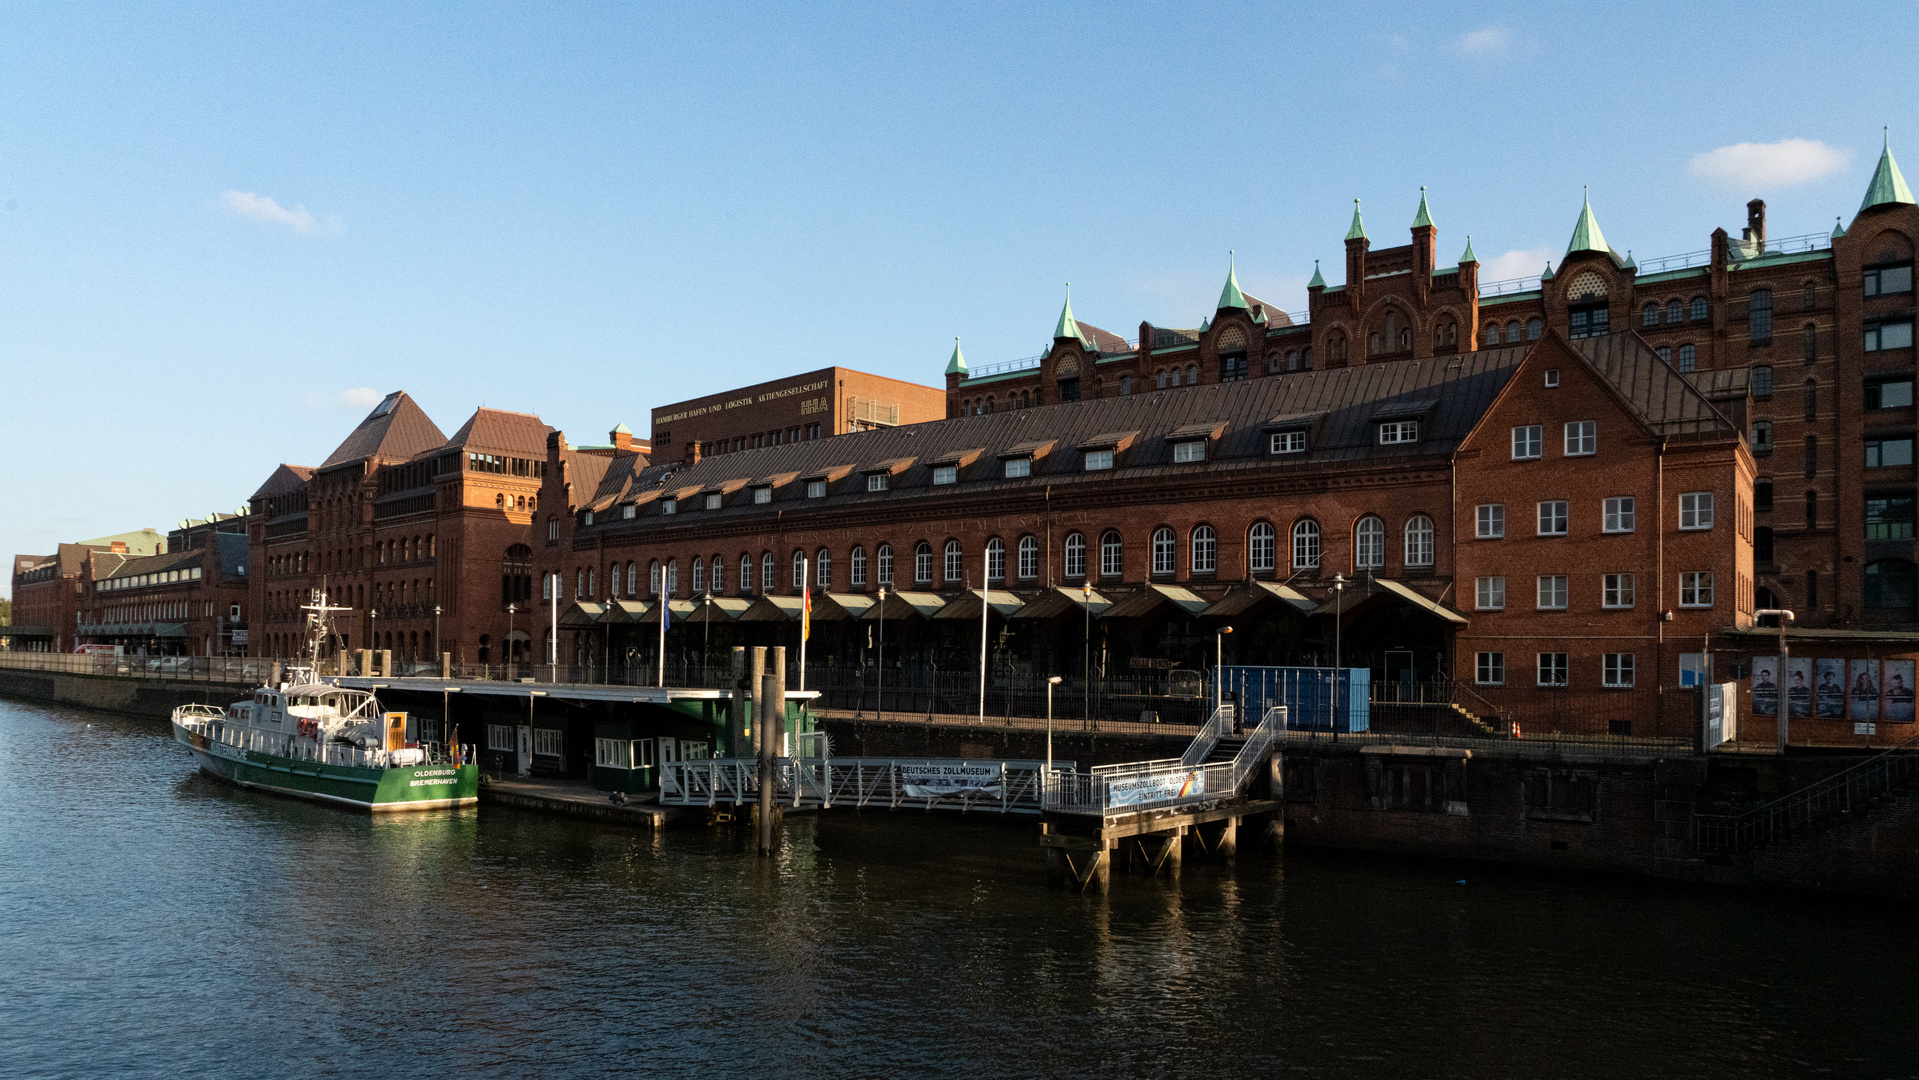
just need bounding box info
[0,2,1919,589]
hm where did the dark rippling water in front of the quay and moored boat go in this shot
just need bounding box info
[0,702,1919,1080]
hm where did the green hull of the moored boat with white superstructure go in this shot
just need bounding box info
[173,723,480,813]
